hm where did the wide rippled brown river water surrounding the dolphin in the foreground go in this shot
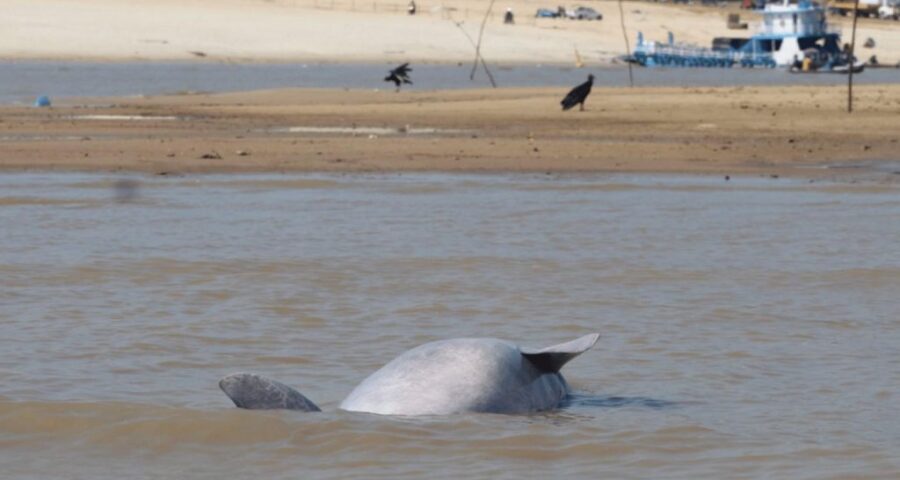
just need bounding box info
[0,173,900,480]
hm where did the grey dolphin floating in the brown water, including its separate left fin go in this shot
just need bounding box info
[219,333,600,415]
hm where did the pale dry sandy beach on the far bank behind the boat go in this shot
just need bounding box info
[0,0,900,65]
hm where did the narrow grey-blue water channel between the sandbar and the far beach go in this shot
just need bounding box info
[0,60,900,104]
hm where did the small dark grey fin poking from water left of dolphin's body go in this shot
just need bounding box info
[219,373,321,412]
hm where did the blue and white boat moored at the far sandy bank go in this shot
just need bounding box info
[629,0,850,71]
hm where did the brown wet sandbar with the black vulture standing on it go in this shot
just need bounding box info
[0,85,900,181]
